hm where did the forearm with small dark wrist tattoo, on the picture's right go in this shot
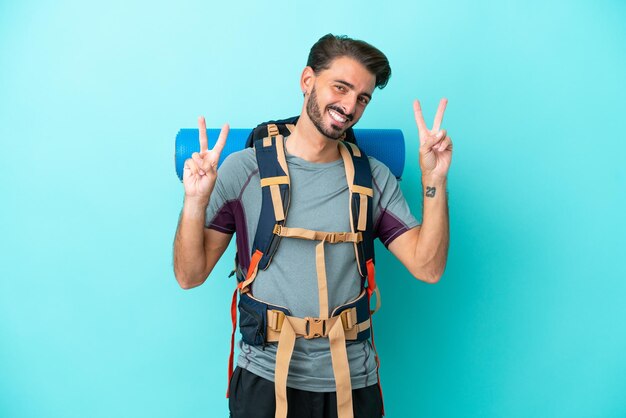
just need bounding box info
[415,177,450,283]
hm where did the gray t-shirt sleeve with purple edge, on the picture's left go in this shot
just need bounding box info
[205,155,244,234]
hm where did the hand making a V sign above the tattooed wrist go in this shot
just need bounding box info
[413,99,452,179]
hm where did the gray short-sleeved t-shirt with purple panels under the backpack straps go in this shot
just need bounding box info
[206,140,418,392]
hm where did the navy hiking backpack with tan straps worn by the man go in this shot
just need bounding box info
[227,117,380,418]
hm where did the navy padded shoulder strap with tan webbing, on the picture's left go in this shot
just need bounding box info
[252,124,290,269]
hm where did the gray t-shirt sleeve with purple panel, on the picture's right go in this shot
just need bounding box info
[370,157,419,247]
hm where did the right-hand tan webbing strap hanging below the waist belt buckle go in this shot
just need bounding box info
[328,321,354,418]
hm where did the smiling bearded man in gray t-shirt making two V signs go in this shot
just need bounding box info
[174,34,452,418]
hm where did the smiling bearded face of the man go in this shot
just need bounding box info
[306,57,376,139]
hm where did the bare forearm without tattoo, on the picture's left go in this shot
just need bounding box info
[174,198,208,289]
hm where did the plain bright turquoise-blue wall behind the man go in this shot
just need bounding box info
[0,0,626,418]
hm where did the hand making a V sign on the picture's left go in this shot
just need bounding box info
[183,116,229,205]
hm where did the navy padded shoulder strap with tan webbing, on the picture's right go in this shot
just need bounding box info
[339,142,374,280]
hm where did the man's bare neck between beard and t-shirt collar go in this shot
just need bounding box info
[286,115,341,163]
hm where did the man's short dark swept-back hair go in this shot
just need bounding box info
[306,33,391,89]
